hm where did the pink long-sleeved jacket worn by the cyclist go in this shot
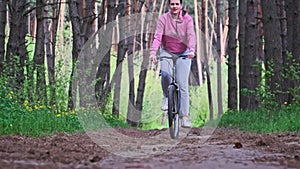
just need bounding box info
[151,11,196,55]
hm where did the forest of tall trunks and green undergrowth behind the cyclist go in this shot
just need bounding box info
[0,0,300,130]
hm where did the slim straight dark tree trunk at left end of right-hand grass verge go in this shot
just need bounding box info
[228,0,238,110]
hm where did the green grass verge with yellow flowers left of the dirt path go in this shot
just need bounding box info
[0,93,128,137]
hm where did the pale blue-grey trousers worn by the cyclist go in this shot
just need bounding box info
[160,49,191,116]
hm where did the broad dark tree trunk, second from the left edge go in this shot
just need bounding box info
[5,0,27,101]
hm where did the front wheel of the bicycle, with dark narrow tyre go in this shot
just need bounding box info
[168,85,179,139]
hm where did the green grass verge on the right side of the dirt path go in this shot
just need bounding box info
[219,105,300,133]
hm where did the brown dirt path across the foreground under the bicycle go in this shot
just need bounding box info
[0,128,300,169]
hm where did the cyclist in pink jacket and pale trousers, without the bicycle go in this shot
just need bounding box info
[150,0,196,128]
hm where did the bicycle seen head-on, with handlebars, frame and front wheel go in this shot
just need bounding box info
[159,52,186,139]
